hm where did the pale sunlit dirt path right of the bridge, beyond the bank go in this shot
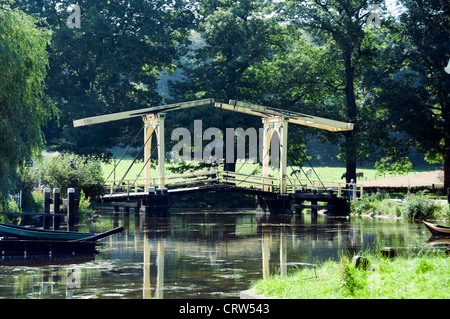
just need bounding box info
[358,171,444,187]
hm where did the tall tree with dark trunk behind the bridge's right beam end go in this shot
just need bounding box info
[272,0,387,182]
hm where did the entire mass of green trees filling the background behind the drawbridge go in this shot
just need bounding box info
[4,0,450,202]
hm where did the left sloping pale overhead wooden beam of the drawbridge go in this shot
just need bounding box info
[73,99,214,127]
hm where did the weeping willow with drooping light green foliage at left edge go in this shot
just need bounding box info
[0,0,56,204]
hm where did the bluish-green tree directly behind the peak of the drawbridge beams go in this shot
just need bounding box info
[170,0,282,129]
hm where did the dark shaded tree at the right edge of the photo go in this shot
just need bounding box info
[379,0,450,201]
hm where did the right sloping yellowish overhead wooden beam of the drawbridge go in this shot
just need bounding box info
[215,100,353,132]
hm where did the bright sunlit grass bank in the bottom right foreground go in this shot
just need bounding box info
[252,254,450,299]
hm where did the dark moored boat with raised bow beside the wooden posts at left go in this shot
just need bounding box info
[0,224,123,258]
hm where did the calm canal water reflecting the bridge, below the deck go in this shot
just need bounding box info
[0,211,442,299]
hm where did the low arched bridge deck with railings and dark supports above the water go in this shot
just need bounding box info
[101,172,347,218]
